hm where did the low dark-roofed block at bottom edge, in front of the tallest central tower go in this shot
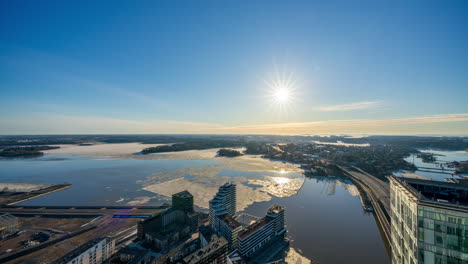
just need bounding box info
[182,234,229,264]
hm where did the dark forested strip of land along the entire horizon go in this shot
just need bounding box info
[0,135,468,150]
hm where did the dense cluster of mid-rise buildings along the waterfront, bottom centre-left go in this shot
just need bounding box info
[31,182,289,264]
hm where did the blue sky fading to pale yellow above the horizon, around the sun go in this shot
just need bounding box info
[0,1,468,134]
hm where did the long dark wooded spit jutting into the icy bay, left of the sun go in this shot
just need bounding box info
[141,140,244,154]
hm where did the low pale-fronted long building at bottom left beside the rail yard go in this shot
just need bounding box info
[55,237,115,264]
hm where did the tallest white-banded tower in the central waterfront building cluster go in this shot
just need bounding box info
[209,182,237,232]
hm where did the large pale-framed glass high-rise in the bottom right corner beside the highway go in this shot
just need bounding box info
[389,176,468,264]
